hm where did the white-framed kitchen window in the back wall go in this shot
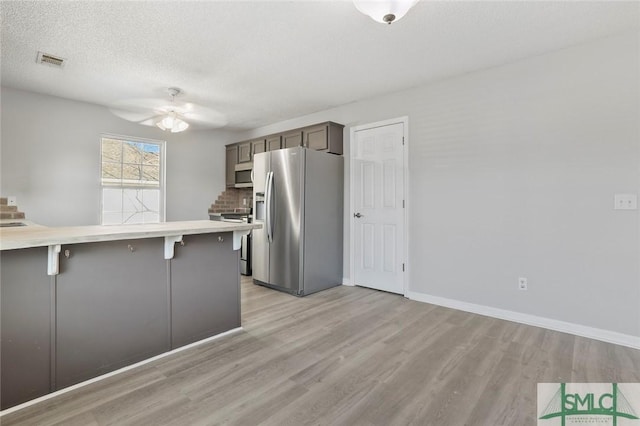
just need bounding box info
[101,136,165,225]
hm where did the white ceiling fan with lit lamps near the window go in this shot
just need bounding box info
[109,87,227,133]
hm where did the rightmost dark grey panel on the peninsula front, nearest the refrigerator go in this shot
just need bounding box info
[171,232,240,348]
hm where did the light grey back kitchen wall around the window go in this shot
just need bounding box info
[0,87,237,226]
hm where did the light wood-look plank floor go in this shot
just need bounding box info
[0,279,640,426]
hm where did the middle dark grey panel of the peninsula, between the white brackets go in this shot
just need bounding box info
[55,238,170,389]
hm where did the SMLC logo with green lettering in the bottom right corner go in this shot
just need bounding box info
[538,383,640,426]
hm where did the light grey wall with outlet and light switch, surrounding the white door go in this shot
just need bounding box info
[236,33,640,336]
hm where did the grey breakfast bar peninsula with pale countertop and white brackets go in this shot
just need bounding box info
[0,220,260,409]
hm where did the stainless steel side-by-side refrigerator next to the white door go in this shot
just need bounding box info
[252,147,344,296]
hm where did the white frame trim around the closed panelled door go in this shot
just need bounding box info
[347,116,410,297]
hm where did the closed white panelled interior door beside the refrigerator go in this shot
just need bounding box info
[351,122,405,294]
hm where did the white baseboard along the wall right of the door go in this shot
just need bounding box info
[406,291,640,349]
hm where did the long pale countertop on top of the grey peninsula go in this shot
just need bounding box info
[0,220,262,250]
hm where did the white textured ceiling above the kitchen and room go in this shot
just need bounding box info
[0,0,640,129]
